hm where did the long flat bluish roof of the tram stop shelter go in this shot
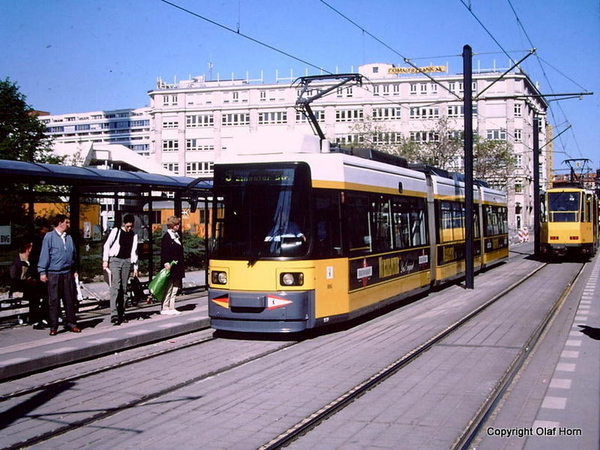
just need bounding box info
[0,160,212,191]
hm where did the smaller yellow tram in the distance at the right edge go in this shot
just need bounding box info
[540,185,600,258]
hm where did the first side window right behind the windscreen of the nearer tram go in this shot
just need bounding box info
[315,191,342,257]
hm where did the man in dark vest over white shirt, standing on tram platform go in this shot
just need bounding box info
[102,214,138,325]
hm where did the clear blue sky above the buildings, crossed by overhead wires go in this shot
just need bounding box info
[0,0,600,169]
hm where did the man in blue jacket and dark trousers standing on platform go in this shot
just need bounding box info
[38,214,81,336]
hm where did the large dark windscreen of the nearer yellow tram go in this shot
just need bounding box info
[212,164,310,261]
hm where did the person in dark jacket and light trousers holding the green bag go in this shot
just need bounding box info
[160,216,185,315]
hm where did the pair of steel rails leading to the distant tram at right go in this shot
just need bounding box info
[259,264,584,450]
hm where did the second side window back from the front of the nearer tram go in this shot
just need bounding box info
[344,193,371,252]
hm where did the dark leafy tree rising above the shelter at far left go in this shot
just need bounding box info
[0,78,60,164]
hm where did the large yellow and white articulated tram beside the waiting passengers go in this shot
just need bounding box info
[208,136,508,333]
